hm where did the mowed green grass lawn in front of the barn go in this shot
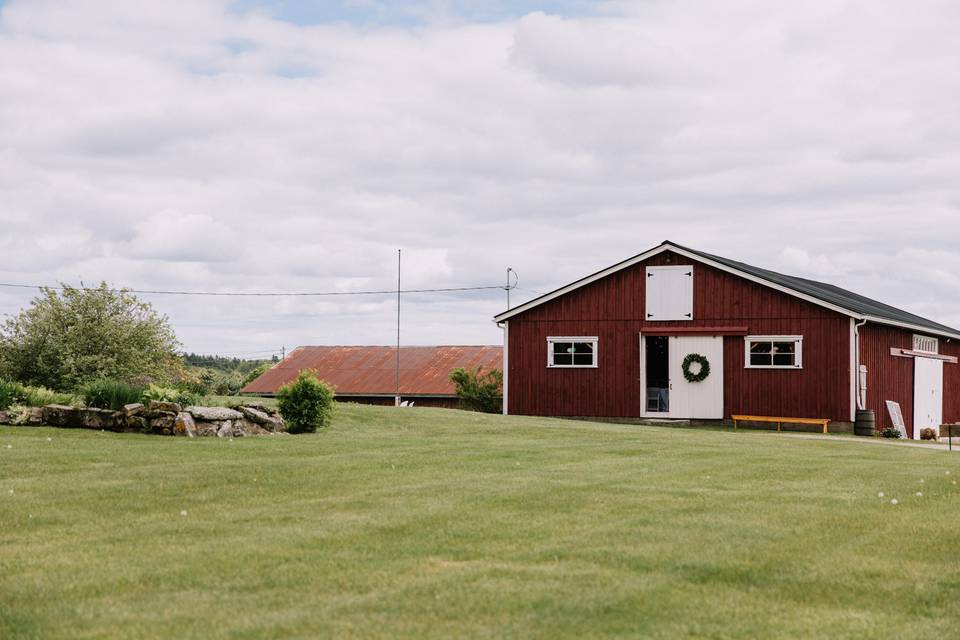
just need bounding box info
[0,405,960,638]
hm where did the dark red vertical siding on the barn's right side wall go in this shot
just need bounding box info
[860,324,960,433]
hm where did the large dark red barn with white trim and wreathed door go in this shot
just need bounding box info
[495,242,960,437]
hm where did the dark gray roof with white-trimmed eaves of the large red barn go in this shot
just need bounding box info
[493,242,960,340]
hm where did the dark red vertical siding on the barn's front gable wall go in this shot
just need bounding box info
[508,253,851,422]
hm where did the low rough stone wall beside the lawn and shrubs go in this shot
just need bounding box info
[0,400,286,438]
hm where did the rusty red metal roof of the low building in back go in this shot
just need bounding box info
[241,346,503,396]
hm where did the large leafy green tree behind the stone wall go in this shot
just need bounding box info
[0,282,183,390]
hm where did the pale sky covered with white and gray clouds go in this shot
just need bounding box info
[0,0,960,357]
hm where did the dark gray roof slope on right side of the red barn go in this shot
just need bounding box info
[663,242,960,335]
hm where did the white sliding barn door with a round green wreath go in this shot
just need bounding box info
[670,336,723,420]
